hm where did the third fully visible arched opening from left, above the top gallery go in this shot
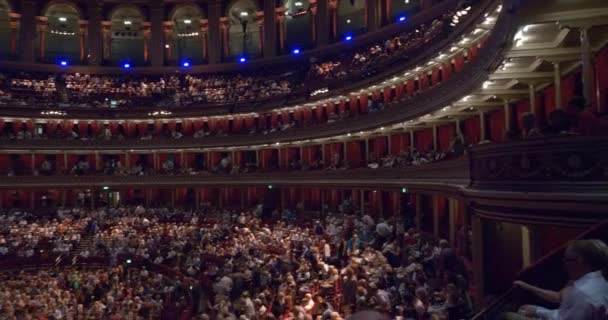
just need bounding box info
[170,4,207,64]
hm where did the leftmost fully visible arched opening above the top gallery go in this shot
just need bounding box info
[42,2,86,63]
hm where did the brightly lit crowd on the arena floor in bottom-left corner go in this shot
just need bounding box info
[0,265,187,320]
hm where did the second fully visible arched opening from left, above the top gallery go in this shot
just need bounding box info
[106,5,148,65]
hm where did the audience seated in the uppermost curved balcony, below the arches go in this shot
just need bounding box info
[0,0,473,107]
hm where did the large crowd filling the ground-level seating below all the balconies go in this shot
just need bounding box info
[0,205,470,319]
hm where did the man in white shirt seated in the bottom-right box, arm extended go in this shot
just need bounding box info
[505,239,608,320]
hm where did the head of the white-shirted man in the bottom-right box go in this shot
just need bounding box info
[564,239,608,280]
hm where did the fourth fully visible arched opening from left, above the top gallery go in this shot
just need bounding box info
[226,0,261,59]
